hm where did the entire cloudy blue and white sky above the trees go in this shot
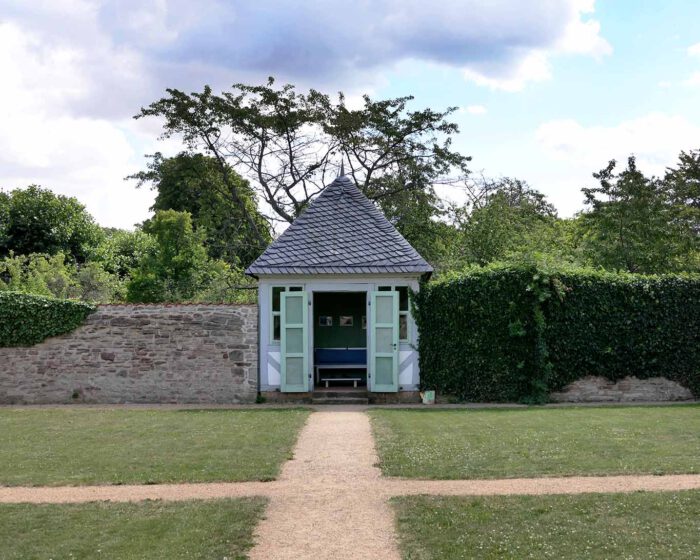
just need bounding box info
[0,0,700,228]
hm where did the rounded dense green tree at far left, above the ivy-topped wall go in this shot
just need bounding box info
[0,185,102,262]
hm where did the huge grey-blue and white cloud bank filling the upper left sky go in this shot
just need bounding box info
[0,0,609,226]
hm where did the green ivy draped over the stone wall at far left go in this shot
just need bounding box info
[0,291,95,348]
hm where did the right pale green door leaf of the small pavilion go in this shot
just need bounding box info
[369,291,399,393]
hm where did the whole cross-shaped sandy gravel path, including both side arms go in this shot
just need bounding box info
[0,408,700,560]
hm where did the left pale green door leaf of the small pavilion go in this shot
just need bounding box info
[280,292,309,393]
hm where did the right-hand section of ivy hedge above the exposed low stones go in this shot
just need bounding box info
[545,272,700,395]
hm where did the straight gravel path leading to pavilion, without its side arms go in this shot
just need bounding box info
[250,411,400,560]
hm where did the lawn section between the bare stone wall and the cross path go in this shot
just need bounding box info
[0,408,309,486]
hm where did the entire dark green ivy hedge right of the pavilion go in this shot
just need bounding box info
[414,265,700,402]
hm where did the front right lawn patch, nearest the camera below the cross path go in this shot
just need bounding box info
[392,490,700,560]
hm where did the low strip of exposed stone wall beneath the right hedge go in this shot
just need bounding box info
[551,375,693,402]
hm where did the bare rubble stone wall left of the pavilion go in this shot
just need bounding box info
[0,305,258,404]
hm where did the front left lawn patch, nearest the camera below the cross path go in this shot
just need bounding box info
[0,498,265,560]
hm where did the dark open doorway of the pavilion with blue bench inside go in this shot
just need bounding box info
[313,292,367,391]
